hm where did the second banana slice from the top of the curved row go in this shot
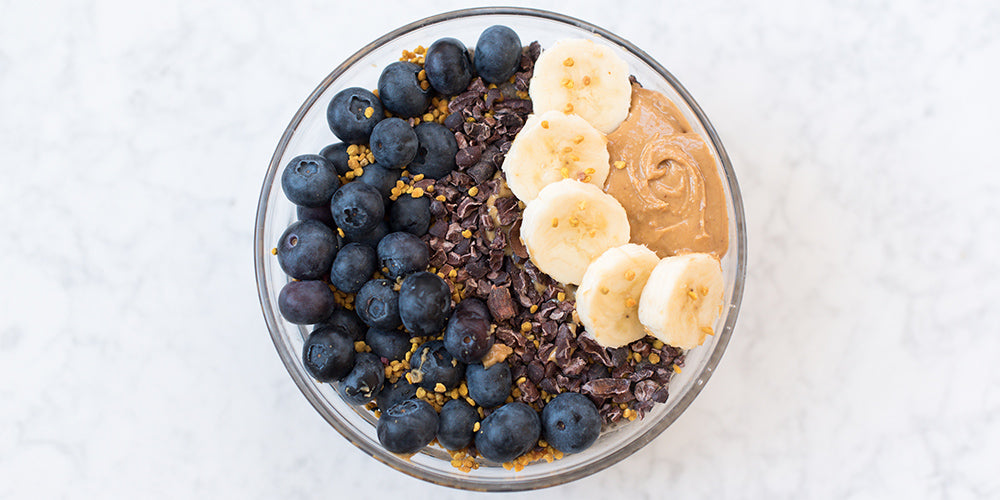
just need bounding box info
[502,111,610,203]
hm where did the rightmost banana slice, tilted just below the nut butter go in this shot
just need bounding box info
[639,253,723,349]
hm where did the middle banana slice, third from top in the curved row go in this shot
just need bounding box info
[521,179,629,284]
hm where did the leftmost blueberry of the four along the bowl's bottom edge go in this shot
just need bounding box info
[375,399,438,453]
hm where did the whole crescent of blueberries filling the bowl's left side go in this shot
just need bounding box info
[276,26,601,468]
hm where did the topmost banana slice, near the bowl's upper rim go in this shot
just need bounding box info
[528,39,632,134]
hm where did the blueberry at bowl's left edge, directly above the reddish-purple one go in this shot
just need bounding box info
[278,220,340,280]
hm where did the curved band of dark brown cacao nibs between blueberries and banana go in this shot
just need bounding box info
[414,42,683,423]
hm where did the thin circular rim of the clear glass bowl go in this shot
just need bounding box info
[254,7,747,491]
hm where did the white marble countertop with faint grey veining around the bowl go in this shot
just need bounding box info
[0,0,1000,499]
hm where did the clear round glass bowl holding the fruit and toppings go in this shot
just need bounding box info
[254,8,746,491]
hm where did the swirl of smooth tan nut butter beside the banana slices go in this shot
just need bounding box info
[604,85,729,258]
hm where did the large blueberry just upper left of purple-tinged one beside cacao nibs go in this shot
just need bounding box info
[399,272,451,336]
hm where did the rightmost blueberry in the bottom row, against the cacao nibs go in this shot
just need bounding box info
[542,392,601,453]
